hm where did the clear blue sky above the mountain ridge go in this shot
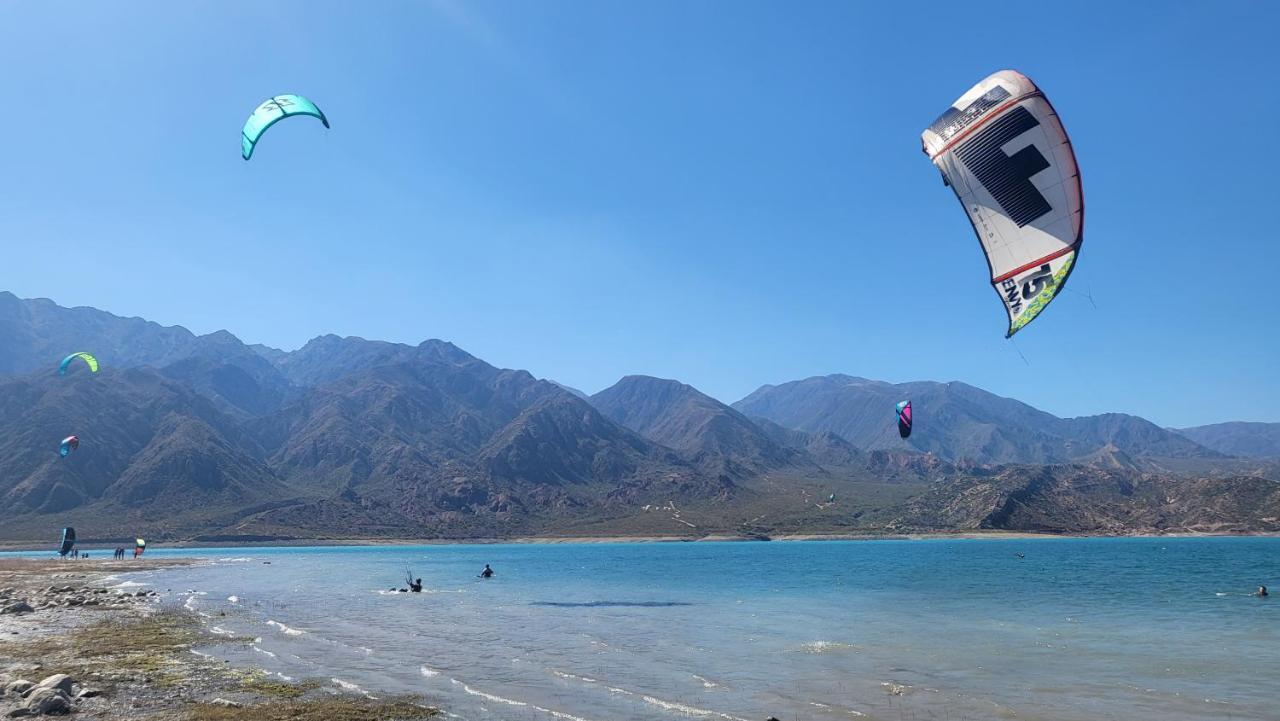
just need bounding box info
[0,0,1280,425]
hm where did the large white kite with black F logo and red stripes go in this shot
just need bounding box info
[922,70,1084,338]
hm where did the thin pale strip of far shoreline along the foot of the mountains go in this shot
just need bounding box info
[0,530,1280,560]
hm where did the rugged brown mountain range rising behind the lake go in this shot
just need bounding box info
[0,292,1280,542]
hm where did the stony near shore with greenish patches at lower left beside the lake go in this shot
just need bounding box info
[0,558,438,721]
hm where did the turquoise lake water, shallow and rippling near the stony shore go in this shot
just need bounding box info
[87,538,1280,721]
